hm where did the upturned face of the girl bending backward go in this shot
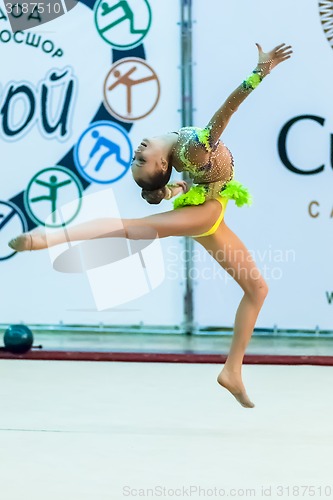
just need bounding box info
[132,137,167,182]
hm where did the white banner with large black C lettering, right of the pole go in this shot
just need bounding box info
[194,0,333,330]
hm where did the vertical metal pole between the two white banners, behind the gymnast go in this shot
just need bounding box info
[180,0,194,335]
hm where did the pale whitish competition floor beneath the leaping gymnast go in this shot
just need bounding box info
[0,360,333,500]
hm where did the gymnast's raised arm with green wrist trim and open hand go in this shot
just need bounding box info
[207,43,292,144]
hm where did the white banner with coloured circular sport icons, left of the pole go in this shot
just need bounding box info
[0,0,184,325]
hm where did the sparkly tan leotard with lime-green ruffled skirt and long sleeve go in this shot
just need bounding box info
[166,61,270,236]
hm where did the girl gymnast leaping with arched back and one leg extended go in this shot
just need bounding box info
[9,44,292,408]
